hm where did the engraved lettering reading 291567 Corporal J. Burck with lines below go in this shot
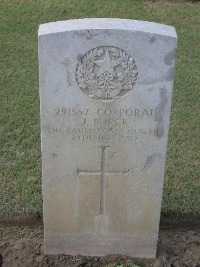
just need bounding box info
[42,106,159,143]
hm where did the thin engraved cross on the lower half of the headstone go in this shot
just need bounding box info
[77,146,130,215]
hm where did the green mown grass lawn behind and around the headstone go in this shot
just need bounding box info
[0,0,200,215]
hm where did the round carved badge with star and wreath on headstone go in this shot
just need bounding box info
[76,46,138,101]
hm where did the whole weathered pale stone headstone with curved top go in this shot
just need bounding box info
[39,19,177,258]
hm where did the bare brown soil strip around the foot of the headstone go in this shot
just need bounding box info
[0,218,200,267]
